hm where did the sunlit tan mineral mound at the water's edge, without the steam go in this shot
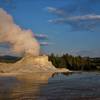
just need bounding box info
[0,54,57,73]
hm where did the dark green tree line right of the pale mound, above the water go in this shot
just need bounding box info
[49,53,100,70]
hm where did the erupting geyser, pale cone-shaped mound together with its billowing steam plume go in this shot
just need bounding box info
[0,8,69,74]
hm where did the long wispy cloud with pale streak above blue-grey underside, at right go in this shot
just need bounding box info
[48,7,100,31]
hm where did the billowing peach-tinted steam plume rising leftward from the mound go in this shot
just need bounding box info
[0,8,40,56]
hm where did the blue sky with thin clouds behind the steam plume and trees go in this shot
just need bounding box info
[0,0,100,57]
